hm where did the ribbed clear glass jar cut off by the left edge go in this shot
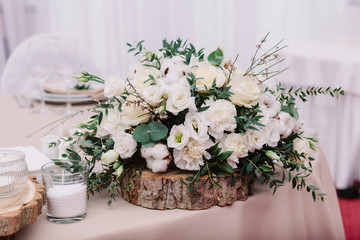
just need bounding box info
[0,149,28,198]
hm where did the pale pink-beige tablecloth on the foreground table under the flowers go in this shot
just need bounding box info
[0,95,345,240]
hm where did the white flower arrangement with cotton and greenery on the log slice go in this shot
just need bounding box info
[58,35,344,204]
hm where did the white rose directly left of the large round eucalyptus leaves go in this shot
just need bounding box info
[112,130,137,159]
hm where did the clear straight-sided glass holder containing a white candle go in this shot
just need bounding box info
[41,160,89,223]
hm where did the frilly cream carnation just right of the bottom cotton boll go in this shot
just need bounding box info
[174,139,214,170]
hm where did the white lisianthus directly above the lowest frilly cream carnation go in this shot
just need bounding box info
[184,112,209,143]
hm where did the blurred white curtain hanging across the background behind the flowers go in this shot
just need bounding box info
[0,0,352,81]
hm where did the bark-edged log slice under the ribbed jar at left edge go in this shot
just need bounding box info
[0,177,46,239]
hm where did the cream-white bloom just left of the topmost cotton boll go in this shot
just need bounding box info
[127,64,161,93]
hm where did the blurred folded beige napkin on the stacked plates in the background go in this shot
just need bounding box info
[44,80,104,98]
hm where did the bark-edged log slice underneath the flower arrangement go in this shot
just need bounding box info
[121,170,249,210]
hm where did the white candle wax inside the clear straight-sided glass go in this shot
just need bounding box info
[46,184,87,218]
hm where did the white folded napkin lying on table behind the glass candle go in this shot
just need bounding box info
[10,146,51,184]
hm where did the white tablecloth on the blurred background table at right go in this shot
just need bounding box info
[278,43,360,188]
